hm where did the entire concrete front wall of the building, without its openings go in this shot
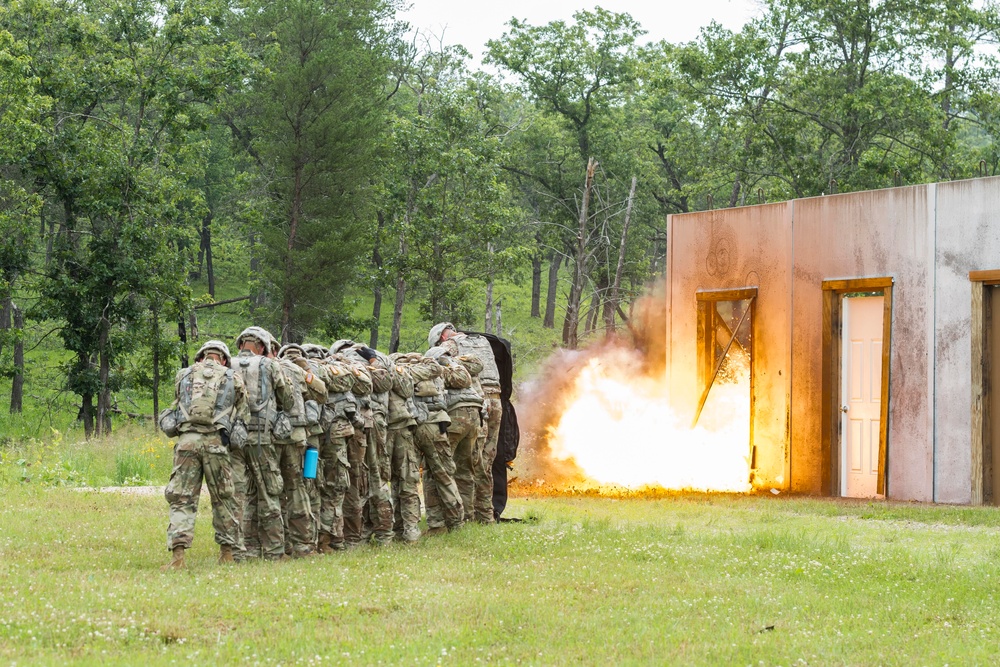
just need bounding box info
[667,178,1000,503]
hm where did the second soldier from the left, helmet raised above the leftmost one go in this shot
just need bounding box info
[233,327,295,560]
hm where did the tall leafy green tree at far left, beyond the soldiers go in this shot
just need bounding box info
[3,0,243,435]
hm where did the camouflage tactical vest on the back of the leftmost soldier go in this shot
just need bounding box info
[176,361,236,431]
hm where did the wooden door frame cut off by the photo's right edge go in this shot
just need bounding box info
[969,270,1000,505]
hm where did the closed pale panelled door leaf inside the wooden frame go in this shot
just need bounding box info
[840,296,884,498]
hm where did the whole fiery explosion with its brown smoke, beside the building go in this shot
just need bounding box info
[522,282,751,493]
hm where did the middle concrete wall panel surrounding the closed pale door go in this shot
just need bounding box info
[792,186,934,500]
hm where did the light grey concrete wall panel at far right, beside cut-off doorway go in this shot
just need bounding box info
[934,178,1000,503]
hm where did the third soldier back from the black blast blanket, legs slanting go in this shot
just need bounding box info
[402,354,464,535]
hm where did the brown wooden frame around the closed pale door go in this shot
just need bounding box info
[821,276,893,497]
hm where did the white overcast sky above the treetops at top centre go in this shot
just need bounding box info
[400,0,758,60]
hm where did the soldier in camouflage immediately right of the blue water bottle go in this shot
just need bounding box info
[314,345,361,554]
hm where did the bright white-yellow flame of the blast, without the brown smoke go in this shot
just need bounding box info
[546,350,750,492]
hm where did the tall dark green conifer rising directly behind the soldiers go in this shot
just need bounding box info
[228,0,399,342]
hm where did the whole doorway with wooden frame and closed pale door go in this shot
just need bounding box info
[822,278,892,498]
